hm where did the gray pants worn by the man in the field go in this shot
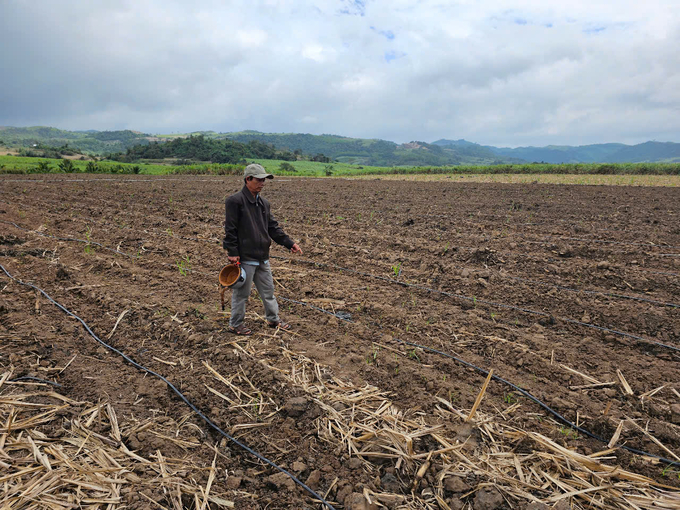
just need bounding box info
[229,263,279,328]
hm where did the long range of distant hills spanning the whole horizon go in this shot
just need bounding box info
[0,126,680,166]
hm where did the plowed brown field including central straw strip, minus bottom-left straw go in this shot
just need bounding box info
[0,176,680,510]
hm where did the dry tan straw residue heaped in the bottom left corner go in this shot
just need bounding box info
[0,371,234,509]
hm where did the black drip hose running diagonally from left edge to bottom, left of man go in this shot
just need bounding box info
[0,264,335,510]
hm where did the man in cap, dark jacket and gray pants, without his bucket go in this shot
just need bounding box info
[222,164,302,335]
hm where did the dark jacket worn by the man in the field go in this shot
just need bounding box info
[222,186,295,262]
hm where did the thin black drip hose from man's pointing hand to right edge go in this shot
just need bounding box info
[271,255,680,352]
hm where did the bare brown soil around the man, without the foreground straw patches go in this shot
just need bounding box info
[0,176,680,509]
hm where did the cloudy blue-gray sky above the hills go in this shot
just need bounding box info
[0,0,680,146]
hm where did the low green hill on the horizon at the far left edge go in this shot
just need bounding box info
[0,126,149,154]
